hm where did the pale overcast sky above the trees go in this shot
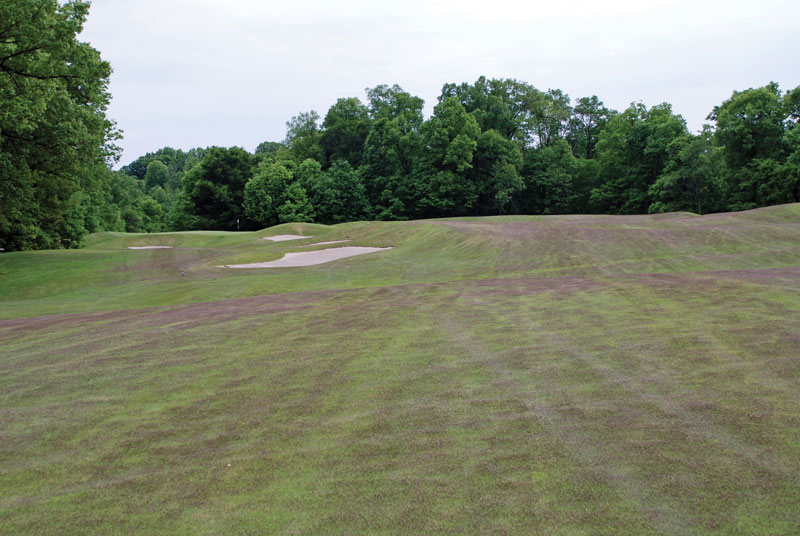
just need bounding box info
[81,0,800,164]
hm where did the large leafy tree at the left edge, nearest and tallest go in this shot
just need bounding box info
[0,0,117,250]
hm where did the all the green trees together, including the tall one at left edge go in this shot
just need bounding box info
[0,0,800,250]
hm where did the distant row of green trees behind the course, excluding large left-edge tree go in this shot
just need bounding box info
[97,77,800,237]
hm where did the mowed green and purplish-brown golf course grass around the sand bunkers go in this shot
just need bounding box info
[0,205,800,535]
